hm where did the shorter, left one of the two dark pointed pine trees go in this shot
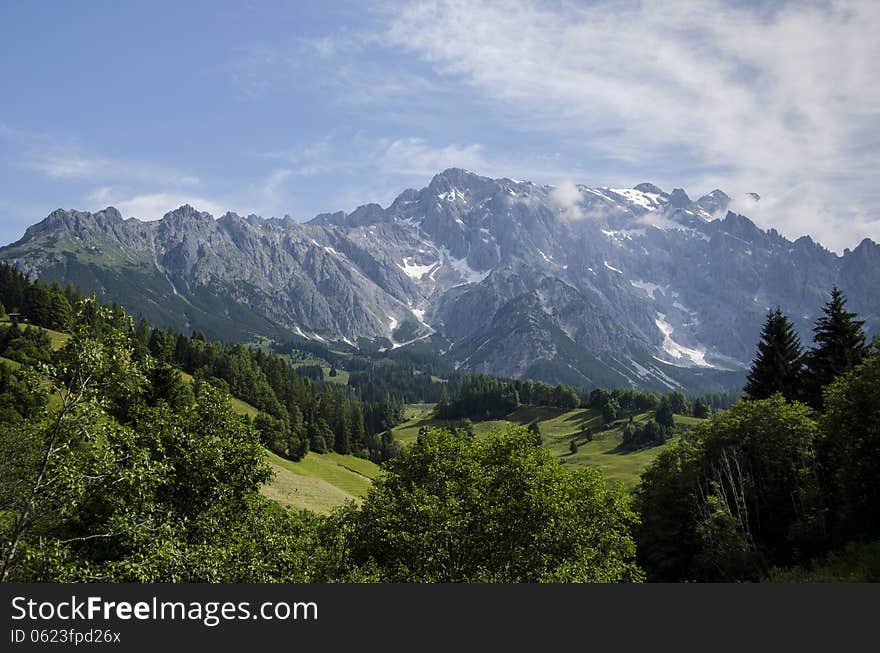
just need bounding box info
[744,307,803,401]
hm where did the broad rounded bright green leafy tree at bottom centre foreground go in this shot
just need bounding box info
[340,428,641,582]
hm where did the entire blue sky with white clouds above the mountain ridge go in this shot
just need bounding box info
[0,0,880,251]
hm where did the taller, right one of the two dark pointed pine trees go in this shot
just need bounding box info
[803,287,868,410]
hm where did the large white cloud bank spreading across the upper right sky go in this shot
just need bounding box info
[384,0,880,248]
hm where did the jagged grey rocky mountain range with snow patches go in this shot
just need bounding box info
[0,169,880,391]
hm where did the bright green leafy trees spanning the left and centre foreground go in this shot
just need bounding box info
[0,302,641,583]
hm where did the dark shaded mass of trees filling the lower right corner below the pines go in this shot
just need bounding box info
[636,354,880,581]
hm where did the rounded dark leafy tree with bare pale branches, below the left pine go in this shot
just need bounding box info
[637,395,825,581]
